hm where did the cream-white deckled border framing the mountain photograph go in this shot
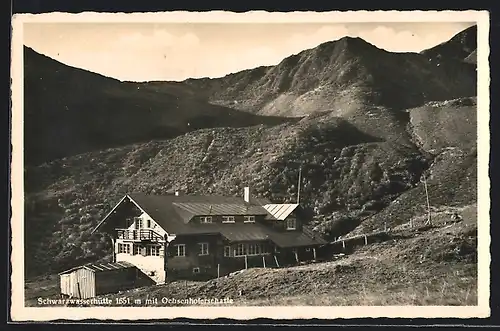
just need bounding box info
[11,10,490,321]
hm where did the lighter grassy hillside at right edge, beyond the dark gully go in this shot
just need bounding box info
[346,98,477,233]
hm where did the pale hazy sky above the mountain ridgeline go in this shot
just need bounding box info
[23,22,474,81]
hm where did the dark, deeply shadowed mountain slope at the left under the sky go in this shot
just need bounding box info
[24,47,294,164]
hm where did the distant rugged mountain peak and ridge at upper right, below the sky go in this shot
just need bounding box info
[186,32,476,117]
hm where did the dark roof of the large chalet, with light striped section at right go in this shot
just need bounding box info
[94,193,323,247]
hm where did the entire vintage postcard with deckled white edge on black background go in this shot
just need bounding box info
[11,10,490,321]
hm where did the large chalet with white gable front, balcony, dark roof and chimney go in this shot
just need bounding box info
[94,187,326,283]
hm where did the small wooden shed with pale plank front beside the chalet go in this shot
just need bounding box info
[59,261,144,299]
